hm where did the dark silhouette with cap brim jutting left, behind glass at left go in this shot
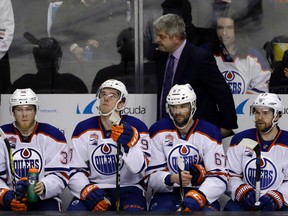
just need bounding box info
[11,33,88,93]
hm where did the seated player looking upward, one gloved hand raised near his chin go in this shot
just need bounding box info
[67,79,150,211]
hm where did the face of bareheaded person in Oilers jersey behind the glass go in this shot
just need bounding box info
[217,17,235,47]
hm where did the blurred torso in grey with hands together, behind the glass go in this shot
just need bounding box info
[50,0,126,62]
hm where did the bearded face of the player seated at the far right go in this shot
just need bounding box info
[254,108,274,132]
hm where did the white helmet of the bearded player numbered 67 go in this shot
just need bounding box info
[166,84,197,127]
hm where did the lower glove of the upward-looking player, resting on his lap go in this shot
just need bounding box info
[80,184,111,211]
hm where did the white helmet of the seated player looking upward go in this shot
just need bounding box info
[96,79,128,114]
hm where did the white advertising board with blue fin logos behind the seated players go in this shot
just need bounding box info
[0,94,288,141]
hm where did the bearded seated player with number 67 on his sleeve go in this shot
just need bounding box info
[147,84,227,212]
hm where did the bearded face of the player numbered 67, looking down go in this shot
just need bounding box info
[169,103,191,127]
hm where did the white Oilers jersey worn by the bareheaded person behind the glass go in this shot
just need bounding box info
[214,49,271,94]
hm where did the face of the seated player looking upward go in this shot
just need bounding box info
[99,88,120,114]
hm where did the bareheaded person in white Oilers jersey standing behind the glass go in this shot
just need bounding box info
[213,15,271,94]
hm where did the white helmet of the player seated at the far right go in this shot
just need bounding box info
[252,93,284,116]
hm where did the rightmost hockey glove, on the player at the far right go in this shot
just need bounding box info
[257,190,284,211]
